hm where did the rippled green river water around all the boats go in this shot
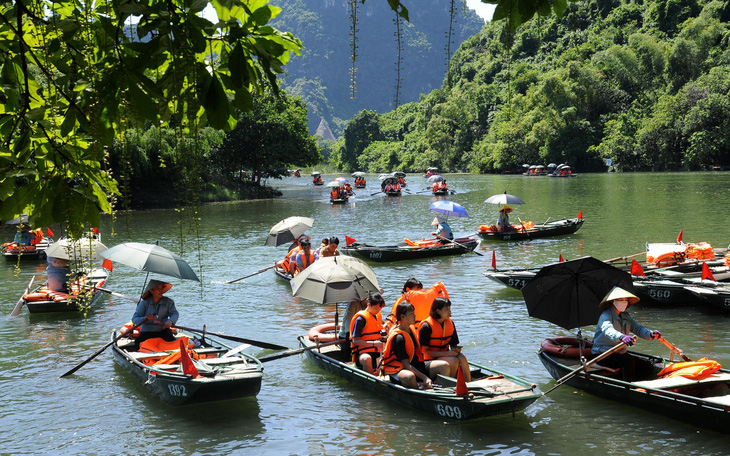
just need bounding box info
[0,173,730,455]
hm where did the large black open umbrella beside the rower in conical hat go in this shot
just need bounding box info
[522,257,633,329]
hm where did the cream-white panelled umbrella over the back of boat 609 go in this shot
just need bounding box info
[291,255,380,304]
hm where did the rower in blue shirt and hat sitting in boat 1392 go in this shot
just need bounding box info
[132,279,180,351]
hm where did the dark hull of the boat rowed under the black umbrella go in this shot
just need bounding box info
[539,350,730,433]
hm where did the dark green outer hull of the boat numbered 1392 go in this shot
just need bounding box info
[112,332,263,405]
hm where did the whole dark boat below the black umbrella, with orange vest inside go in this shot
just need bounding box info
[538,336,730,433]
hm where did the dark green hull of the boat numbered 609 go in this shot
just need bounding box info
[299,336,540,420]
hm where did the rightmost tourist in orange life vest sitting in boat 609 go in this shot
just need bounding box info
[418,297,471,382]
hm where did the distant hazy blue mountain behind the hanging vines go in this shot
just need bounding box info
[271,0,484,136]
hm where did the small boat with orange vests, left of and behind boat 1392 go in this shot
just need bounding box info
[22,268,109,313]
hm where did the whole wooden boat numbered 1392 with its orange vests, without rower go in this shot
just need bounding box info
[111,331,264,405]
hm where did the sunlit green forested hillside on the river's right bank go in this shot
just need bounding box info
[333,0,730,172]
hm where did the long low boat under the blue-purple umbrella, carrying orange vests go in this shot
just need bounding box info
[340,237,479,262]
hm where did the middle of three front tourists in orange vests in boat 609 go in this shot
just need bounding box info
[383,302,449,389]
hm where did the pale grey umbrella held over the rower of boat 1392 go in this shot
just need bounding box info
[101,242,200,282]
